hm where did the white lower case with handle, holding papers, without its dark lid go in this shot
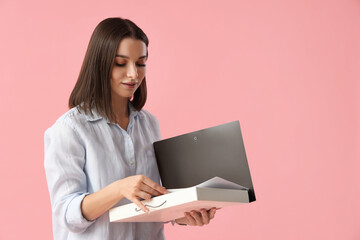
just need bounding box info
[109,177,249,222]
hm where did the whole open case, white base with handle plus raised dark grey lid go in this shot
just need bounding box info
[109,121,256,222]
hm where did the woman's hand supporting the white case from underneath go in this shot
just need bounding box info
[175,208,216,227]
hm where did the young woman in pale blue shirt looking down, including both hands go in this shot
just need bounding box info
[45,18,216,240]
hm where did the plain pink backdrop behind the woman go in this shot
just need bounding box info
[0,0,360,240]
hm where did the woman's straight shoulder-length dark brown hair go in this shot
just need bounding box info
[69,18,149,122]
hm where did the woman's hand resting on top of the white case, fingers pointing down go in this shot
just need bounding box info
[117,175,168,213]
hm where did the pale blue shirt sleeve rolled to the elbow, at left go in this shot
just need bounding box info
[44,120,95,233]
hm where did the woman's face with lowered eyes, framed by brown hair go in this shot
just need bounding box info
[111,38,147,100]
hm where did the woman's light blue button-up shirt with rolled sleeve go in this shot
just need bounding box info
[44,103,164,240]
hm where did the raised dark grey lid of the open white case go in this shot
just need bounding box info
[154,121,256,202]
